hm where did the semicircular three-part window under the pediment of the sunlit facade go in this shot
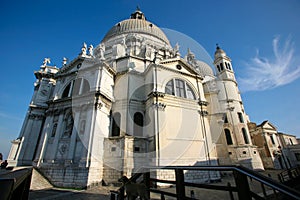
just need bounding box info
[165,79,196,100]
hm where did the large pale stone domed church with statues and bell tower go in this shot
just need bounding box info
[8,9,298,188]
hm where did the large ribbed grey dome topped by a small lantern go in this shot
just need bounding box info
[102,10,170,45]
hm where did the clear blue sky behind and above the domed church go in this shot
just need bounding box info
[0,0,300,157]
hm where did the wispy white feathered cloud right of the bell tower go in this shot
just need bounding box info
[239,36,300,91]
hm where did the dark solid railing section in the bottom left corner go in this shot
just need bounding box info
[0,167,32,200]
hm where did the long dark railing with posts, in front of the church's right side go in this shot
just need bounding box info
[111,166,300,200]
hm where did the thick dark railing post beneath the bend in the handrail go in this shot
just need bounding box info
[233,171,252,200]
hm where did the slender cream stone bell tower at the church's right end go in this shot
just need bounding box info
[214,45,263,169]
